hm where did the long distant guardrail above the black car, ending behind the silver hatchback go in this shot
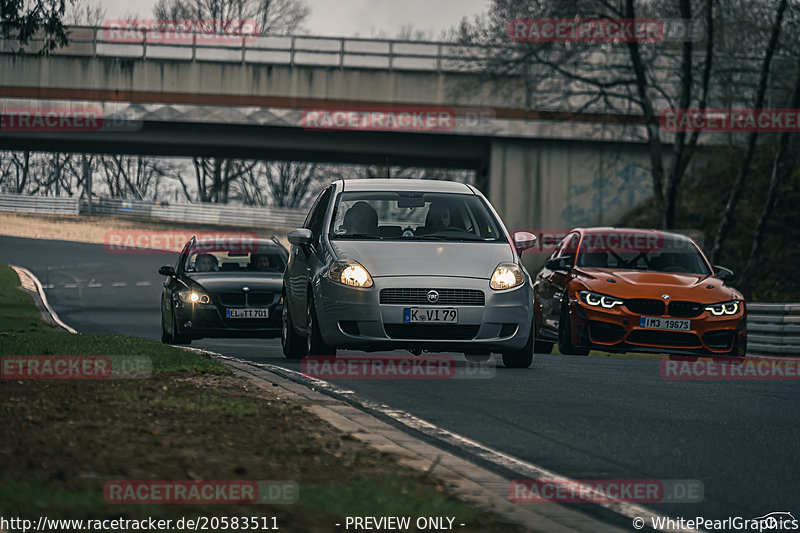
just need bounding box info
[81,198,306,228]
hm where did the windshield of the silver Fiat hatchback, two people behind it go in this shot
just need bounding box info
[330,191,506,241]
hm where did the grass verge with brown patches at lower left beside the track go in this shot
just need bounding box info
[0,265,522,533]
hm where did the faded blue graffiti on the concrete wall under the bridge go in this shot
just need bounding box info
[561,163,652,226]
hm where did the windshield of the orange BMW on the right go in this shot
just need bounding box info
[577,232,711,275]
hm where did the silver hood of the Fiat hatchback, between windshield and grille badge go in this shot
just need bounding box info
[331,239,515,279]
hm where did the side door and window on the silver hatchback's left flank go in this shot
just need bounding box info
[286,187,332,329]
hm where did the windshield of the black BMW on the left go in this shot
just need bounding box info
[184,246,286,274]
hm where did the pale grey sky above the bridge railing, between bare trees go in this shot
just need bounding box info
[102,0,488,39]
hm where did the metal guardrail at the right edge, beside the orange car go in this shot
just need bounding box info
[747,303,800,355]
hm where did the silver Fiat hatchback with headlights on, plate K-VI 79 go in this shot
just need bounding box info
[281,179,536,368]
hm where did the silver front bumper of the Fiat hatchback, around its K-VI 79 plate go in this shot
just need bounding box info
[314,276,533,353]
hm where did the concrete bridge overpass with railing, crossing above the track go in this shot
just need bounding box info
[0,28,688,266]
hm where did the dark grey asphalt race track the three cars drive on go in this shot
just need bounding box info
[0,237,800,527]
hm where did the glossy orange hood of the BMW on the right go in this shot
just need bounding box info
[575,268,743,303]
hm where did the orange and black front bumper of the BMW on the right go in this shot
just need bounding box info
[570,300,747,356]
